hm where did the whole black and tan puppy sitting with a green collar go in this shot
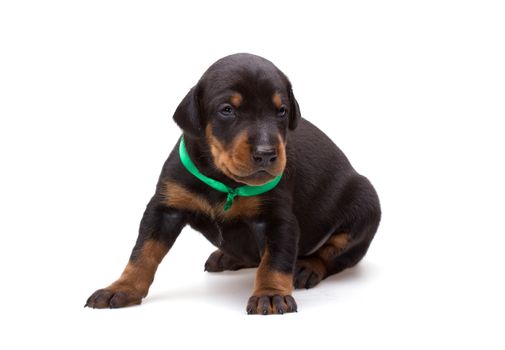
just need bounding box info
[86,54,381,314]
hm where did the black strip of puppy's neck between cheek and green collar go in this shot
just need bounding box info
[184,134,244,188]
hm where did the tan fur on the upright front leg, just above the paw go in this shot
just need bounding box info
[253,249,293,296]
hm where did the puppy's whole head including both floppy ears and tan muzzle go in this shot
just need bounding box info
[174,54,300,185]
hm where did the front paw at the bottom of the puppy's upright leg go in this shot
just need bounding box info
[247,295,297,315]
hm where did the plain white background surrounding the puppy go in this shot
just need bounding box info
[0,0,505,349]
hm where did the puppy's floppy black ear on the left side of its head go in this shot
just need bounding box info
[174,86,203,137]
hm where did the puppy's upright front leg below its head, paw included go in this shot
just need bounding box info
[247,217,299,315]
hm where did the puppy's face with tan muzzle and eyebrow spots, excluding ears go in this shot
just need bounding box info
[204,76,289,185]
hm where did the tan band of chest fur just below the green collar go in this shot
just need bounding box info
[164,181,261,222]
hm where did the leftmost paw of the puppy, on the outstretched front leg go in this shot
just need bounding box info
[84,286,143,309]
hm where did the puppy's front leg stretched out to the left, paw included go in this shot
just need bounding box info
[85,196,185,308]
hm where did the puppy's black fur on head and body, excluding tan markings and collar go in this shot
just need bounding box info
[85,54,381,312]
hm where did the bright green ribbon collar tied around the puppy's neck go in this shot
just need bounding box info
[179,137,282,211]
